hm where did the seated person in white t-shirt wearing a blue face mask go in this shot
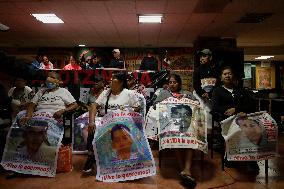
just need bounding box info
[20,72,77,124]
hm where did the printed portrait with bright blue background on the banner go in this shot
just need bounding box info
[96,120,151,174]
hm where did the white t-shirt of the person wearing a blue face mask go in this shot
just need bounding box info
[31,88,76,113]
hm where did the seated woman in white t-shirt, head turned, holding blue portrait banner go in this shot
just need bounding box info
[84,72,140,172]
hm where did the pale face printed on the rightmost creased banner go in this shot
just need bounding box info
[240,119,262,144]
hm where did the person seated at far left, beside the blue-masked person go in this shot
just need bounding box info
[8,78,34,120]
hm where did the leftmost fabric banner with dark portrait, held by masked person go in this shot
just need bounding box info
[1,111,63,177]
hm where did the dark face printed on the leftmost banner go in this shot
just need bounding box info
[26,130,46,154]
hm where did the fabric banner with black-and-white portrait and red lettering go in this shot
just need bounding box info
[157,97,208,153]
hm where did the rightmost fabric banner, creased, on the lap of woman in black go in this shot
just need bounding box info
[221,112,278,161]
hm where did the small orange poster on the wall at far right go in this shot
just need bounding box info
[256,65,275,89]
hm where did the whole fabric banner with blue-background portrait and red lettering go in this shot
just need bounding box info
[93,110,156,182]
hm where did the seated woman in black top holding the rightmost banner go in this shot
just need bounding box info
[212,67,259,171]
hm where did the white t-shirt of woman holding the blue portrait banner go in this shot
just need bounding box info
[96,89,139,115]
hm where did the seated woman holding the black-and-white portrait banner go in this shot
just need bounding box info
[154,74,196,187]
